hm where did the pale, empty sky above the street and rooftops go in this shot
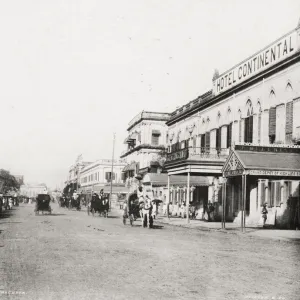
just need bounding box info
[0,0,300,187]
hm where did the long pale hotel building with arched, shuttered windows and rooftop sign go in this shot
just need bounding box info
[165,20,300,226]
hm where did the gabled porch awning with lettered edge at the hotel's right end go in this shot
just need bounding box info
[222,145,300,177]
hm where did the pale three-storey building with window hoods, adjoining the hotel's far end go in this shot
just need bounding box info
[121,111,170,190]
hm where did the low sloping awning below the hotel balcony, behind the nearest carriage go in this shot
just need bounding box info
[143,173,209,186]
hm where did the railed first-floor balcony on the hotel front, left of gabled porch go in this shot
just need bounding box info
[166,147,229,163]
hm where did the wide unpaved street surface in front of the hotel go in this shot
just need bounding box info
[0,204,300,300]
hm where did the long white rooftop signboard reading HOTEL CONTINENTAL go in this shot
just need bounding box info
[213,31,297,95]
